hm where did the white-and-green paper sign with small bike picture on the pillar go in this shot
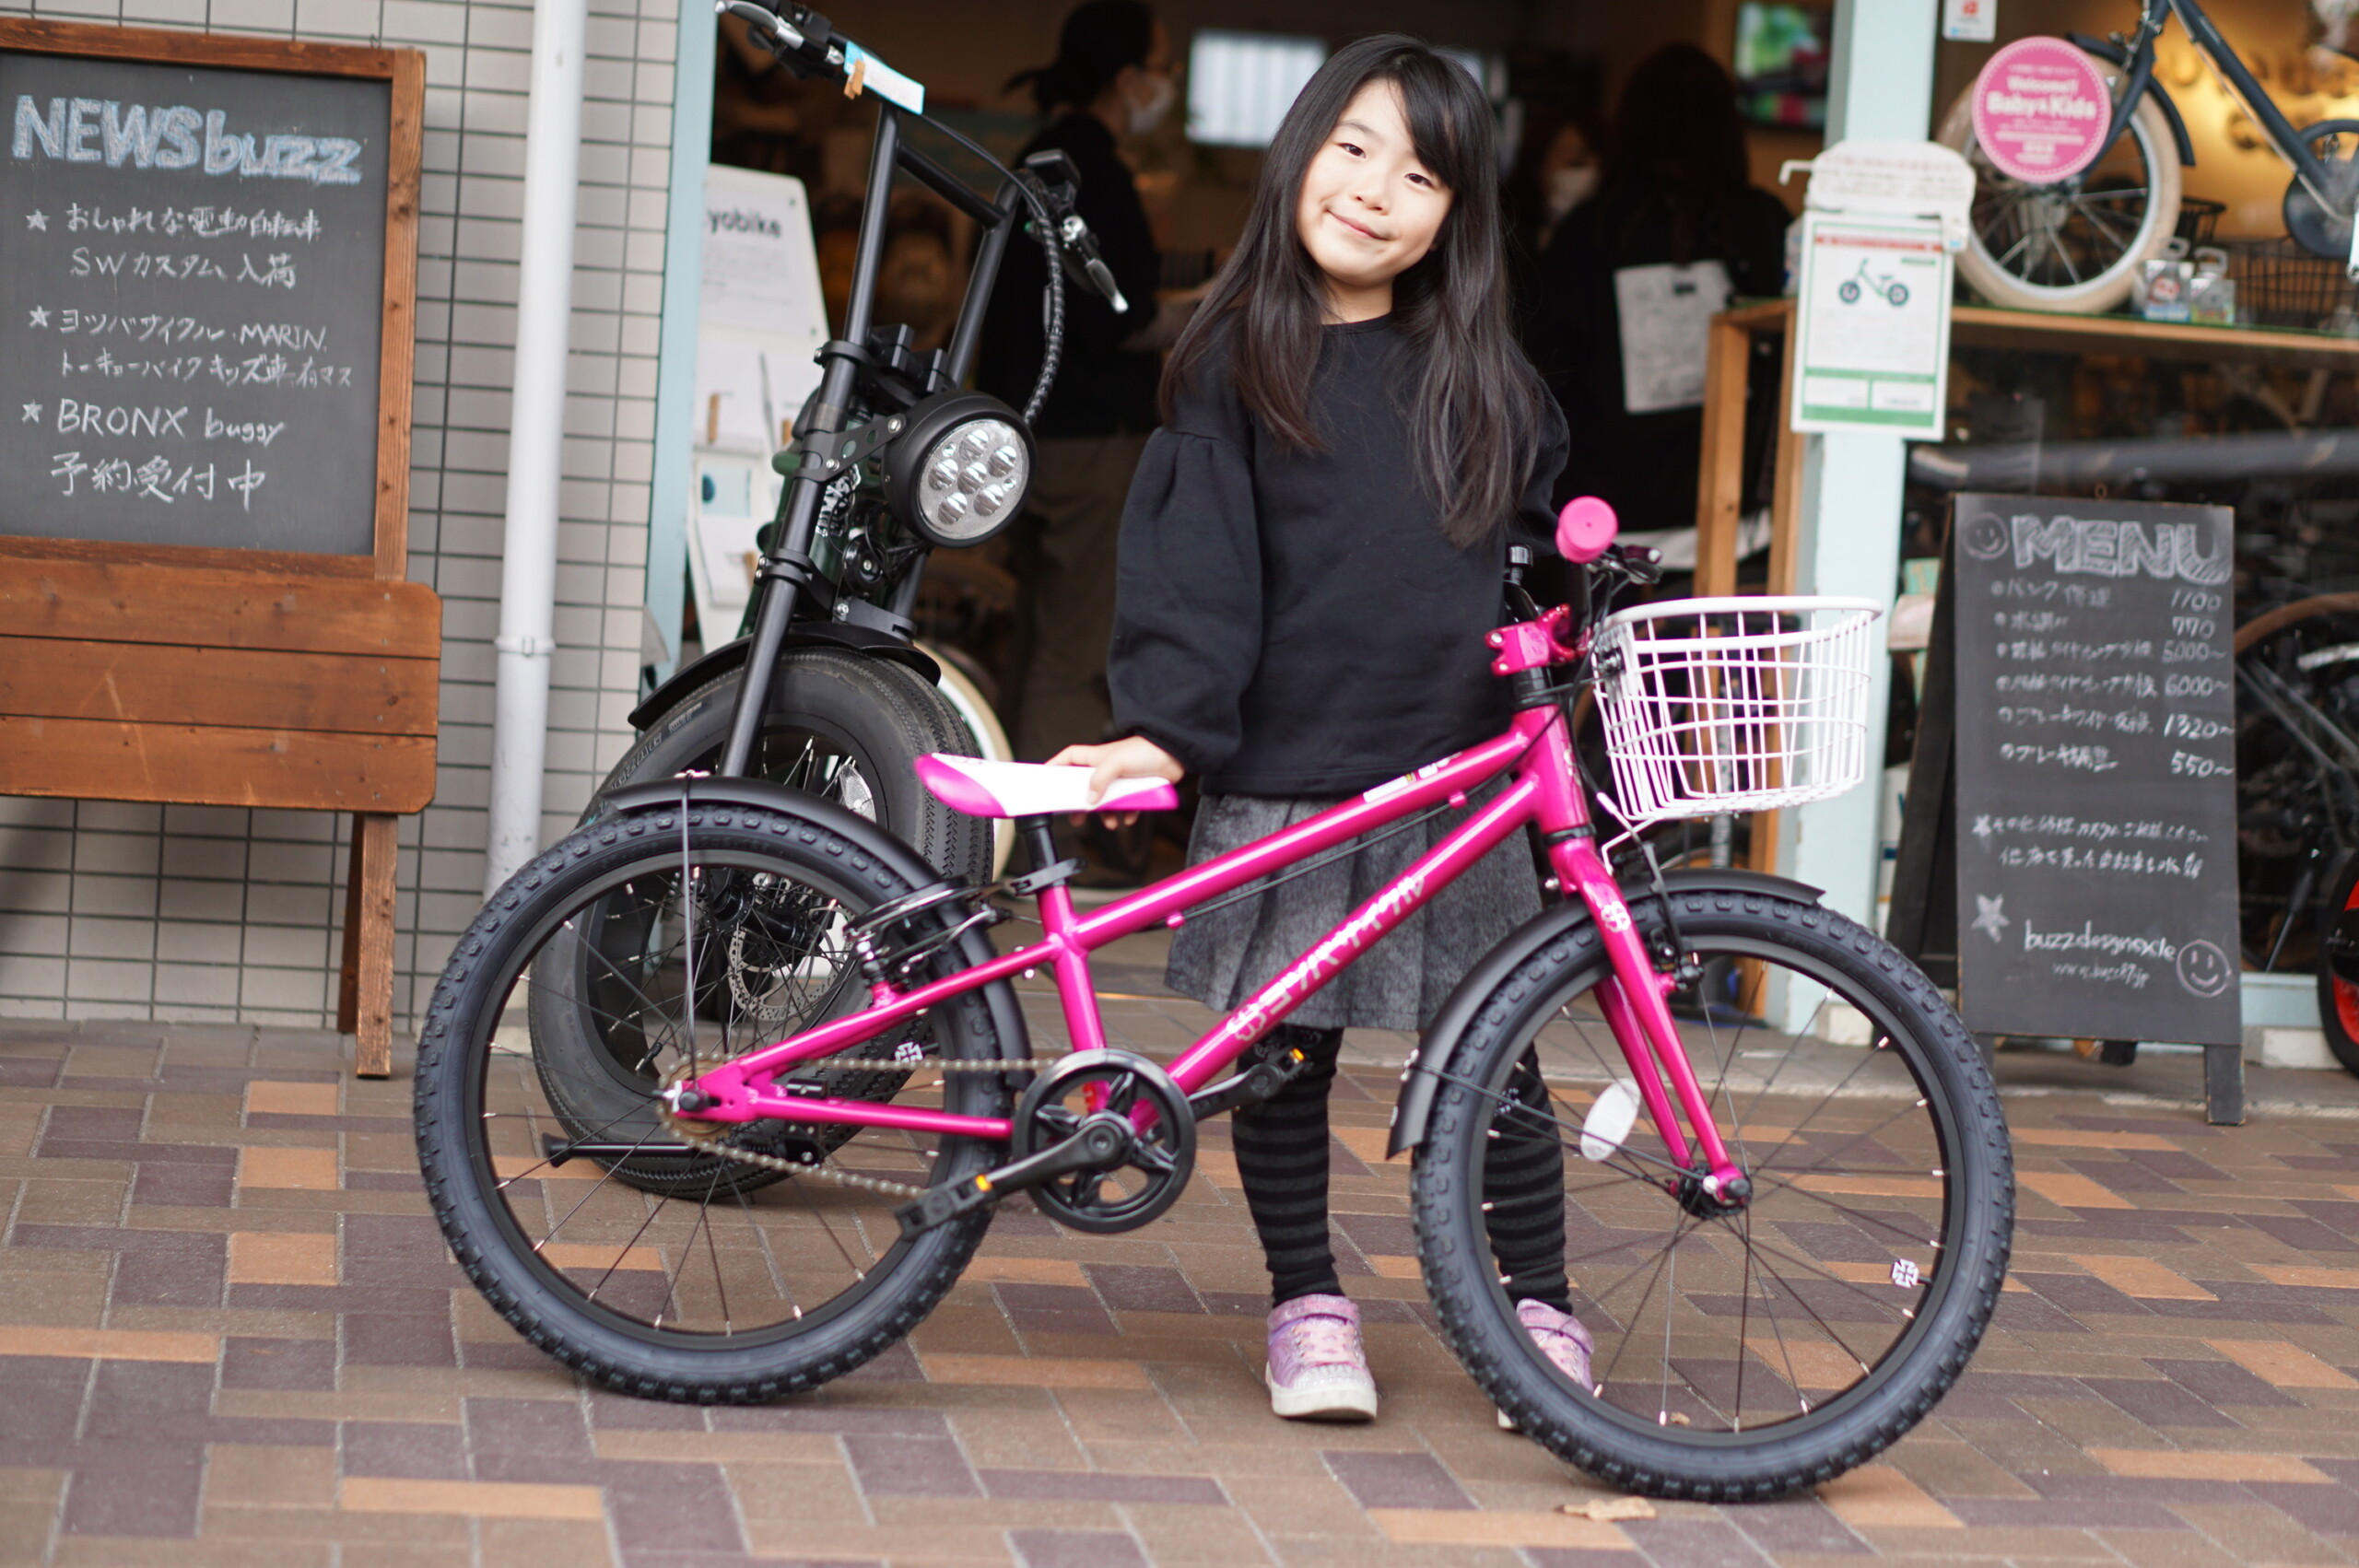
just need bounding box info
[1793,212,1951,441]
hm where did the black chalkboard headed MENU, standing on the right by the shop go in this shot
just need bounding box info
[1951,495,2241,1045]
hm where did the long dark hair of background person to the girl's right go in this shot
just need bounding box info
[1597,42,1753,266]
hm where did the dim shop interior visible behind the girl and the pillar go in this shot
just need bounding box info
[689,0,2359,1051]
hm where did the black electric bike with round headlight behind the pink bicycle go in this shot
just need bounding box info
[604,0,1125,882]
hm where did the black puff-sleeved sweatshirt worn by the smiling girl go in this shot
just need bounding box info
[1107,316,1567,797]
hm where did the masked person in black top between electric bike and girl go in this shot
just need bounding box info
[977,0,1177,762]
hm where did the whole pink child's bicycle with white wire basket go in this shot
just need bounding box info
[417,502,2014,1500]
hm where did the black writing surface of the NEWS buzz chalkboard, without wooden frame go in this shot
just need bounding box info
[0,50,389,556]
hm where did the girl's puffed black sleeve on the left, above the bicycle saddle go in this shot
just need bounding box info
[1107,420,1273,773]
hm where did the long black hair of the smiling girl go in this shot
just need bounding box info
[1163,33,1547,549]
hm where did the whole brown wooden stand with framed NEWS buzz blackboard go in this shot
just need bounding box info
[0,17,441,1075]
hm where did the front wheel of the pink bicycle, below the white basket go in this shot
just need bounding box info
[1413,891,2014,1502]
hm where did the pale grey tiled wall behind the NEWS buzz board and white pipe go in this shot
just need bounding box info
[0,0,698,1030]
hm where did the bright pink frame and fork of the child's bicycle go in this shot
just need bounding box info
[689,608,1741,1190]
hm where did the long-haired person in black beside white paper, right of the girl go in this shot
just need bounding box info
[1526,45,1788,532]
